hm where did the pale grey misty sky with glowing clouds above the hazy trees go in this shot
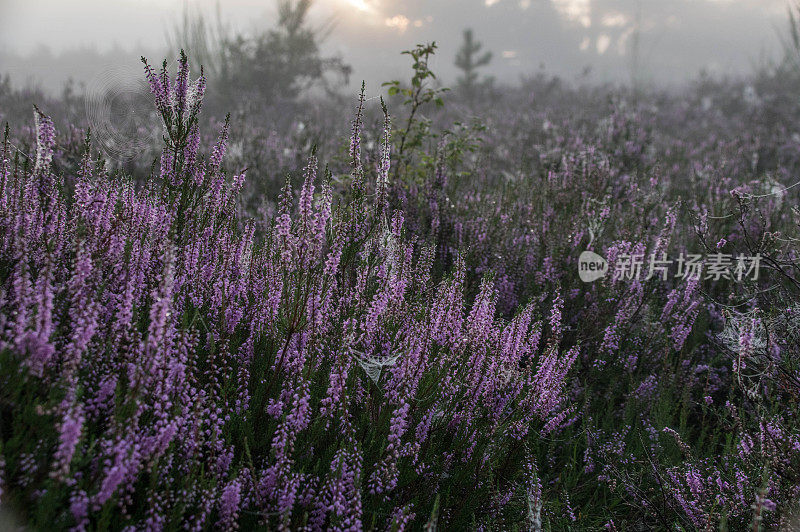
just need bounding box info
[0,0,788,91]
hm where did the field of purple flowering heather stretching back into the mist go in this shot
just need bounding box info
[0,8,800,531]
